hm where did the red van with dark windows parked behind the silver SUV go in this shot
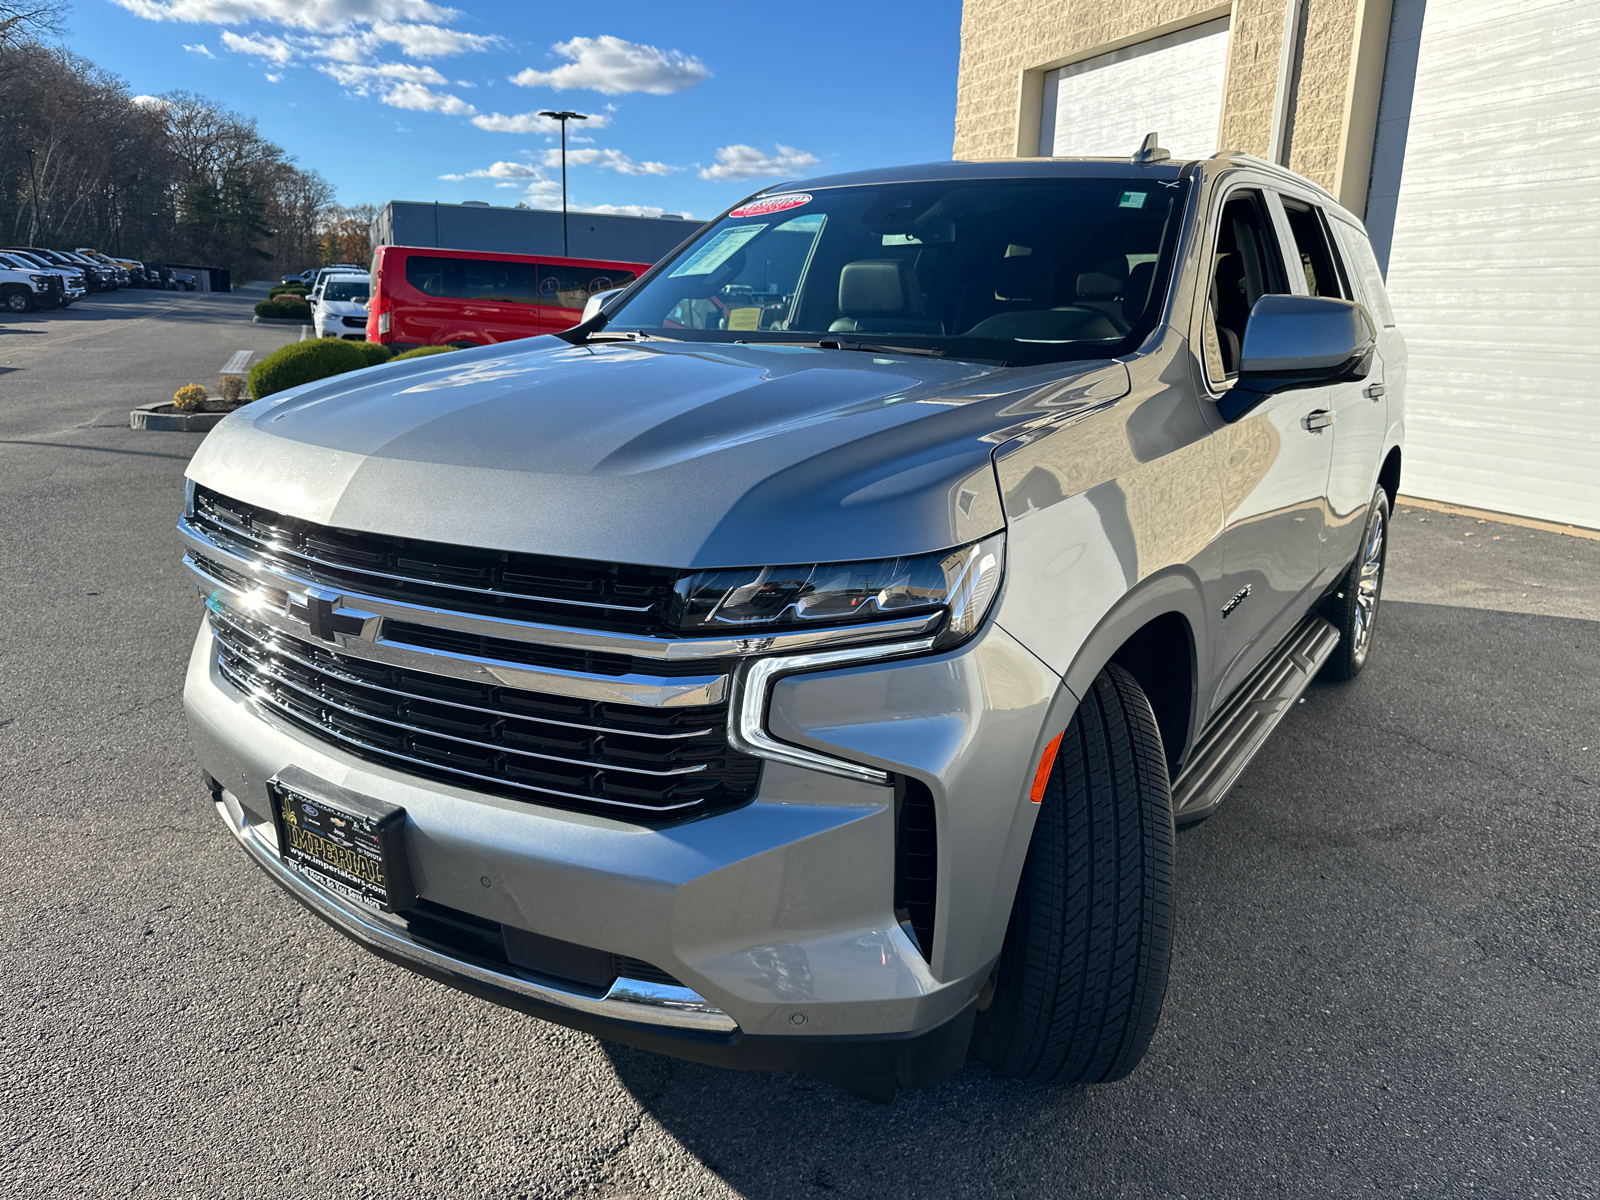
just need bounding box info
[366,246,650,350]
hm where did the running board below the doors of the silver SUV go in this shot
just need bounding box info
[1173,616,1339,826]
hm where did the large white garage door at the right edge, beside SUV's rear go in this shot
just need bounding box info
[1389,0,1600,528]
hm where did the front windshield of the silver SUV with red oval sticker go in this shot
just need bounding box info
[606,179,1189,365]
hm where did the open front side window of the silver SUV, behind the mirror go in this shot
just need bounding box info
[1202,190,1290,387]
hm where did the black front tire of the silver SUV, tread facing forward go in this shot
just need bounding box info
[973,666,1173,1085]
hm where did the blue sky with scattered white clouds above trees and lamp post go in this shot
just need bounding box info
[67,0,962,218]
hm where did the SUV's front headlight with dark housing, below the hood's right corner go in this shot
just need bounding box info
[672,533,1005,648]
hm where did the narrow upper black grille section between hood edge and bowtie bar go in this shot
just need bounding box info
[190,488,678,634]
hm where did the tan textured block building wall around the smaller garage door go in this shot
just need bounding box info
[955,0,1389,211]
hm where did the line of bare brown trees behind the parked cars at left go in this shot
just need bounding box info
[0,0,373,282]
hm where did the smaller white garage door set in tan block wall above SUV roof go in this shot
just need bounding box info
[1038,18,1227,158]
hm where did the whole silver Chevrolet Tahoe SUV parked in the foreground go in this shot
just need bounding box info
[179,149,1406,1099]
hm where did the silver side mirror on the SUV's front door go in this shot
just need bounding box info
[1216,296,1378,421]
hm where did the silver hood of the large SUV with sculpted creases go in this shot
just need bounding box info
[187,338,1128,568]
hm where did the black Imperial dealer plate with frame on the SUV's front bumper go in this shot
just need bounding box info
[267,766,416,912]
